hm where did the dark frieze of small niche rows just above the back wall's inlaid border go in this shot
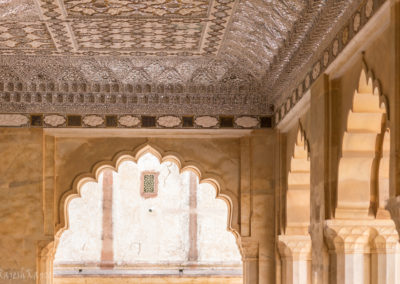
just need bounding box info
[0,82,273,116]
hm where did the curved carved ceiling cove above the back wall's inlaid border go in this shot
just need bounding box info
[0,56,272,120]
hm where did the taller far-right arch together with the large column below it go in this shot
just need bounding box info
[324,63,398,283]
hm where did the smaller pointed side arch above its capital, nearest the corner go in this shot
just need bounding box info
[285,125,310,235]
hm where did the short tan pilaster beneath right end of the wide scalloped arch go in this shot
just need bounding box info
[241,239,259,284]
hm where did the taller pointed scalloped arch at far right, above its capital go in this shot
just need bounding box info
[335,62,389,219]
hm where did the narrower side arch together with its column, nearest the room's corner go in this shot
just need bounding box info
[278,125,311,284]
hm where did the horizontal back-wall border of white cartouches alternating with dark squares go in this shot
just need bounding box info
[0,113,272,129]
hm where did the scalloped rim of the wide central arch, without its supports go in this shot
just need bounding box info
[55,143,240,244]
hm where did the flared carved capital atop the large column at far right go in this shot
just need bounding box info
[324,219,399,254]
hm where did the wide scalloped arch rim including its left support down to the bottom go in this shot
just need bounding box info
[38,144,243,284]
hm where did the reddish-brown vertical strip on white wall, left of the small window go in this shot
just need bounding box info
[100,170,114,269]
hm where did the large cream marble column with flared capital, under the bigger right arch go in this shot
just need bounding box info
[324,219,398,284]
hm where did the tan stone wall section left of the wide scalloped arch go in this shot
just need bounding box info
[0,129,45,284]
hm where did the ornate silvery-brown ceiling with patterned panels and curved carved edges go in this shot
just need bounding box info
[0,0,380,124]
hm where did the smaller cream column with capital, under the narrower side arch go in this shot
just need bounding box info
[278,235,311,284]
